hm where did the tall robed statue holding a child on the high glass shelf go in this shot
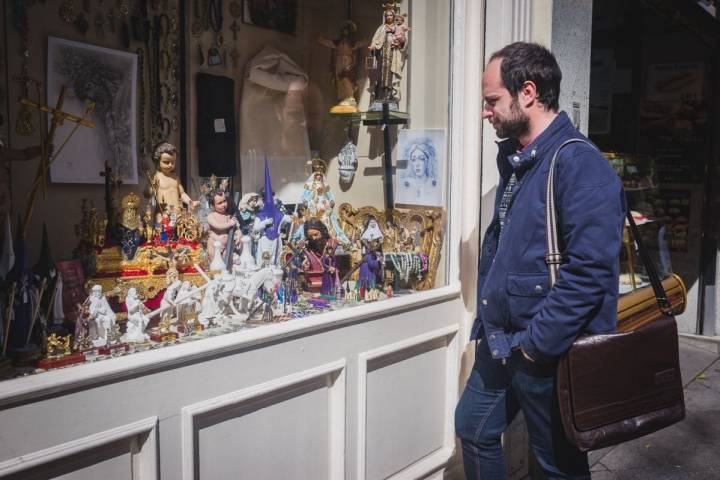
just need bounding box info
[368,1,409,111]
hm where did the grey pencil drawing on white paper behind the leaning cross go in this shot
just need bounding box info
[47,37,138,184]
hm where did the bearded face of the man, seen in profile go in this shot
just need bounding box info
[482,58,530,139]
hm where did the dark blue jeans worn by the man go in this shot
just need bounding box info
[455,340,590,480]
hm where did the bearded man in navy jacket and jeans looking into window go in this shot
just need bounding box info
[455,43,625,479]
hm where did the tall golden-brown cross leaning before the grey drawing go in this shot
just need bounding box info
[20,86,95,236]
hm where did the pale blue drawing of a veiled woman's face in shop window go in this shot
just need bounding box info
[395,129,445,207]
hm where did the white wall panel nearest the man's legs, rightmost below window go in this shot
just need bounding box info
[357,325,459,479]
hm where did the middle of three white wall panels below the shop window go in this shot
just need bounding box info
[182,360,345,479]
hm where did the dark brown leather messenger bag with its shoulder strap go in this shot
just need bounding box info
[546,139,685,451]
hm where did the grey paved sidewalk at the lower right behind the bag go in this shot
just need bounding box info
[590,338,720,480]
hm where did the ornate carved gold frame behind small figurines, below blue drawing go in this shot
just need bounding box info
[338,203,445,290]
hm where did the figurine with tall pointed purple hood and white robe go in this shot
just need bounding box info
[253,159,292,265]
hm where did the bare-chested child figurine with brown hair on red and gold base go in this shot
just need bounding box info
[150,143,198,223]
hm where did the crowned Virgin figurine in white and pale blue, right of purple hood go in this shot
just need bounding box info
[300,158,350,245]
